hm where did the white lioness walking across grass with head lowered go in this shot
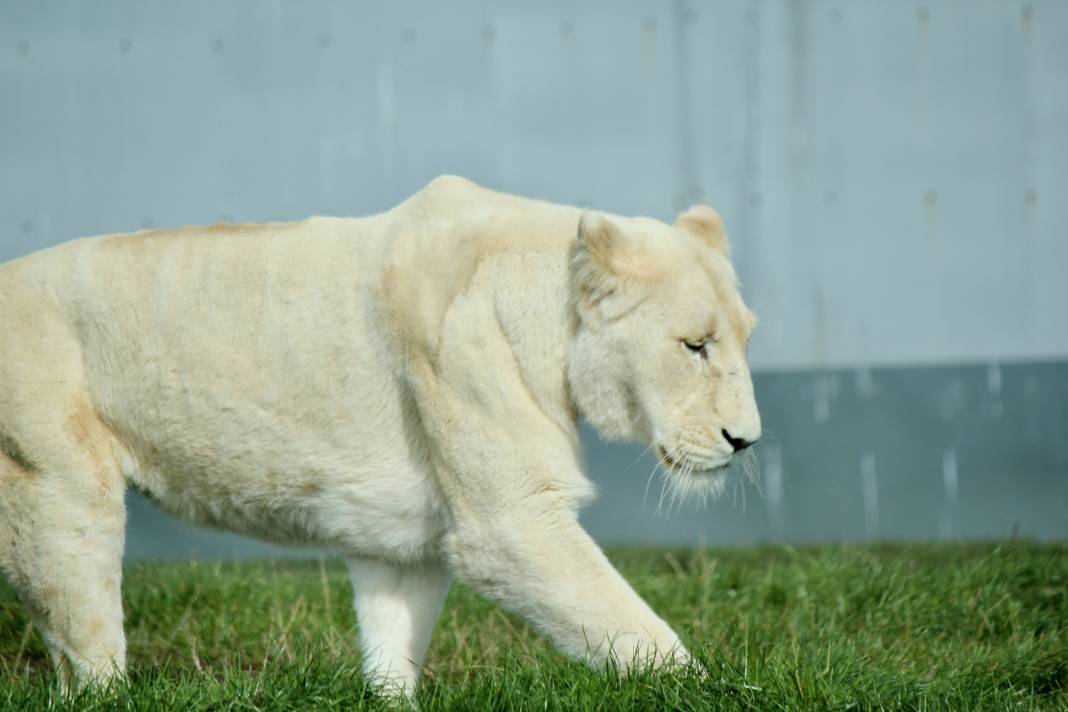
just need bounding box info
[0,177,760,693]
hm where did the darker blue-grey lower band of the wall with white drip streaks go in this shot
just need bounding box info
[121,361,1068,558]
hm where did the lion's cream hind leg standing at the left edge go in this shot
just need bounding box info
[0,412,126,690]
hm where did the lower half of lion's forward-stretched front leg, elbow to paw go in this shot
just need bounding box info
[447,502,689,668]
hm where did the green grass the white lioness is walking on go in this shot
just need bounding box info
[0,543,1068,711]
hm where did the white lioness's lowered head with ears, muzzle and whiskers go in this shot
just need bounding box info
[568,207,760,491]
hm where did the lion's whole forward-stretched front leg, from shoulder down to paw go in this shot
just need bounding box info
[397,291,688,667]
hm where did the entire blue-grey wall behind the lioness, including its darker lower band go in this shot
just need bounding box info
[0,0,1068,556]
